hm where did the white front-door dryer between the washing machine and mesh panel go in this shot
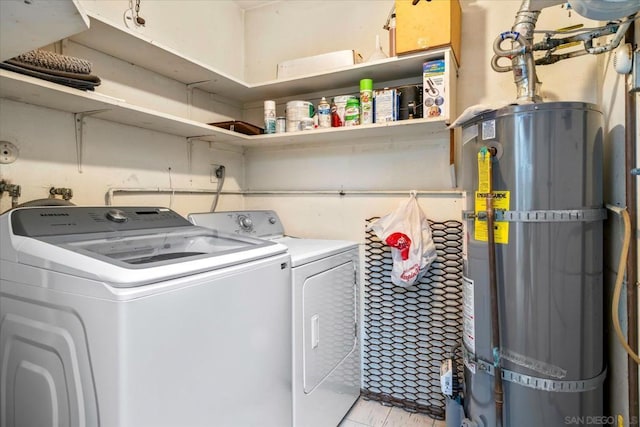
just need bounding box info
[188,211,361,427]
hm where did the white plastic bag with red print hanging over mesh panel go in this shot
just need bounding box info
[367,191,436,288]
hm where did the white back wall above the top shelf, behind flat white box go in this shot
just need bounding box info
[245,0,394,83]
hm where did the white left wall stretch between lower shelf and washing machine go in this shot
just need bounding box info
[0,100,243,215]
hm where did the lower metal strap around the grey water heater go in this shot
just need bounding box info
[462,346,607,393]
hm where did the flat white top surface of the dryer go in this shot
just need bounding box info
[272,236,358,267]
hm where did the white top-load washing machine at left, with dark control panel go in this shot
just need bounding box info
[0,207,292,427]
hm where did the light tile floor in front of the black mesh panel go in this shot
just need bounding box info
[338,398,446,427]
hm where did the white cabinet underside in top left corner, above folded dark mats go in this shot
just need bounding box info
[0,0,89,61]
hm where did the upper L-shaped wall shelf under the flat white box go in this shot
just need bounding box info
[70,16,449,102]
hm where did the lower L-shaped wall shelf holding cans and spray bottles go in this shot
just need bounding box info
[0,70,447,147]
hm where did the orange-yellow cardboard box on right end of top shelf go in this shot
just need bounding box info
[395,0,462,65]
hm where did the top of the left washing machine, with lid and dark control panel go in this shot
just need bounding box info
[2,206,286,287]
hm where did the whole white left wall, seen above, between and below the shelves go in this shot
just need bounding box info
[0,0,244,214]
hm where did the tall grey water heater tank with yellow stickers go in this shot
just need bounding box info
[462,102,606,427]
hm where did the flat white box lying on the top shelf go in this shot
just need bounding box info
[277,50,362,79]
